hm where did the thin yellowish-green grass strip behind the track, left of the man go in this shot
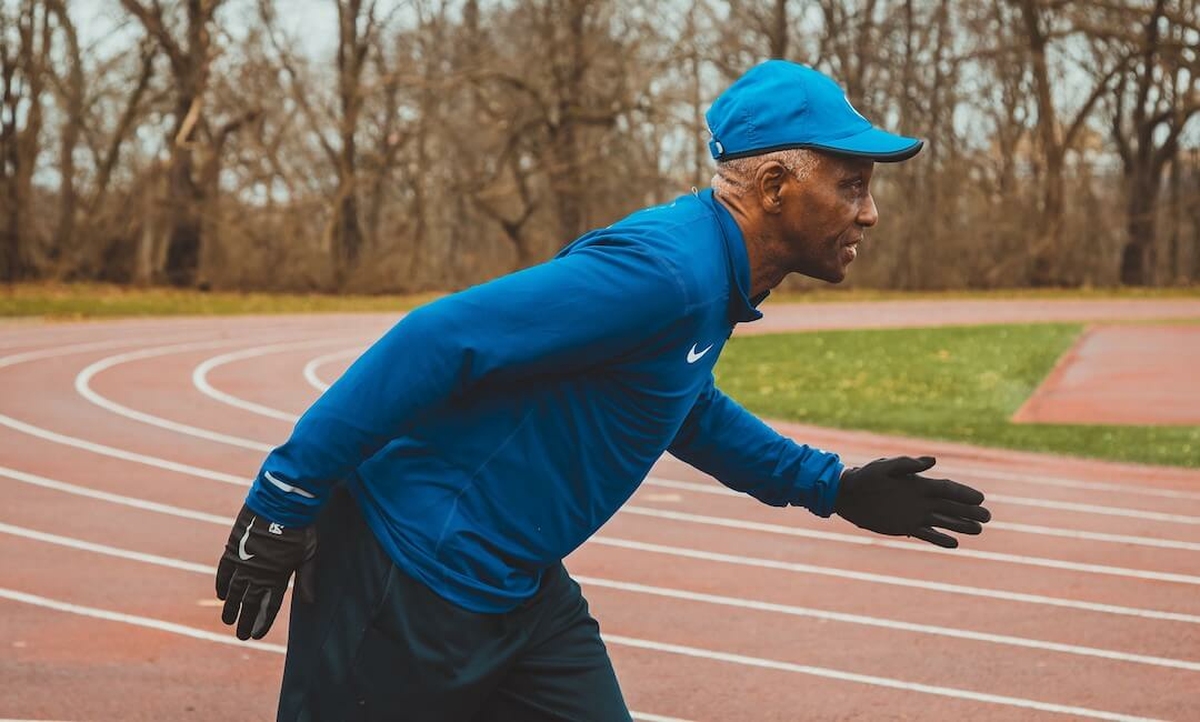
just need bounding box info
[0,283,436,320]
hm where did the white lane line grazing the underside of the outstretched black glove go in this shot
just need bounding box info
[620,504,1200,584]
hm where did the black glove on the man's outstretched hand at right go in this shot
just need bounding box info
[834,456,991,549]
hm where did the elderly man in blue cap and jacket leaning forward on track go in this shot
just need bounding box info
[217,61,989,722]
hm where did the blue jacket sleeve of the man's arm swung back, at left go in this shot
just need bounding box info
[246,239,686,527]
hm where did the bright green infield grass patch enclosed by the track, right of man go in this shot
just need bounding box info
[716,324,1200,467]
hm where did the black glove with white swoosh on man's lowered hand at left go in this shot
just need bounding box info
[217,505,317,639]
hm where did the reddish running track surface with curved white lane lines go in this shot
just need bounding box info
[0,301,1200,721]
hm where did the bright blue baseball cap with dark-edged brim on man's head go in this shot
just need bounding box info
[704,60,924,163]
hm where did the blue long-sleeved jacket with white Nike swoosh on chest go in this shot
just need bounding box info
[246,191,842,613]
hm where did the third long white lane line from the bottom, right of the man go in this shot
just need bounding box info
[587,534,1200,624]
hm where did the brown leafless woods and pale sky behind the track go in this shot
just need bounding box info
[0,0,1200,293]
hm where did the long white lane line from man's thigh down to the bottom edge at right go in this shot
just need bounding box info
[604,634,1156,722]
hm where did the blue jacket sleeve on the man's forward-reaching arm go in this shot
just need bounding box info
[667,378,844,517]
